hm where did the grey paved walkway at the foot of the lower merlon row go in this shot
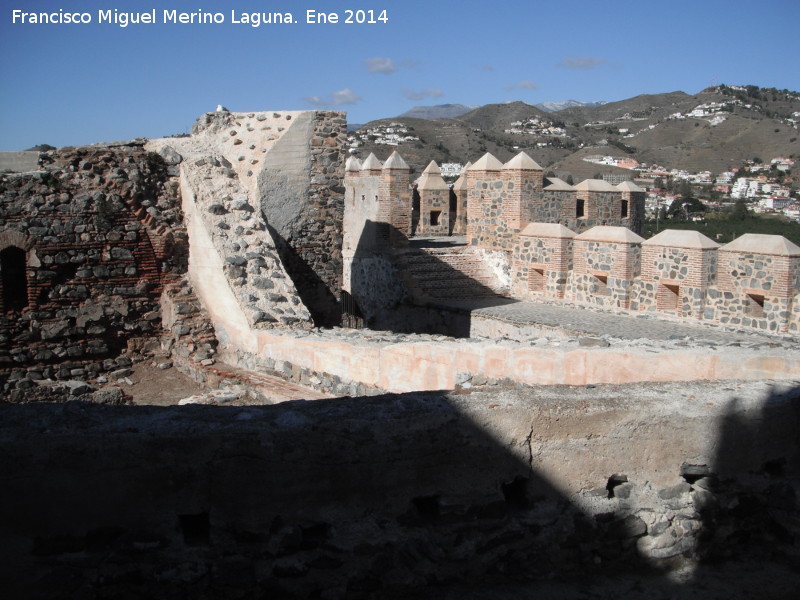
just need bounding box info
[436,298,800,348]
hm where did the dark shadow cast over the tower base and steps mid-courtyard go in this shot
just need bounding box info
[349,220,513,337]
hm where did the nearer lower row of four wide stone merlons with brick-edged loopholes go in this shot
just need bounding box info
[512,224,800,333]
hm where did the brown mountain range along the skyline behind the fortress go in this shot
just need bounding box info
[350,85,800,181]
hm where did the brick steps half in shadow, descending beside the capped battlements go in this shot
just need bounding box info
[394,247,508,304]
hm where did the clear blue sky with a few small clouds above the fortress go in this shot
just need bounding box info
[0,0,800,150]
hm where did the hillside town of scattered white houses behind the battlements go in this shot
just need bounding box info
[347,85,800,229]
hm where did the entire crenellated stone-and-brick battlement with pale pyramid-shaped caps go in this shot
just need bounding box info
[345,147,800,333]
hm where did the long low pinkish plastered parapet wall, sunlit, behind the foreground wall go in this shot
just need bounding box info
[212,323,800,392]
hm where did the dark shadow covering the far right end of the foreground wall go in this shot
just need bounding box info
[681,383,800,600]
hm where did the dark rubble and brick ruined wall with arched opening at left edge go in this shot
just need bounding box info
[0,142,188,396]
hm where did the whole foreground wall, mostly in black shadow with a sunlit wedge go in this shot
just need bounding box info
[0,383,800,598]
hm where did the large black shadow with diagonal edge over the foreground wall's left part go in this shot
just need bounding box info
[0,393,680,599]
